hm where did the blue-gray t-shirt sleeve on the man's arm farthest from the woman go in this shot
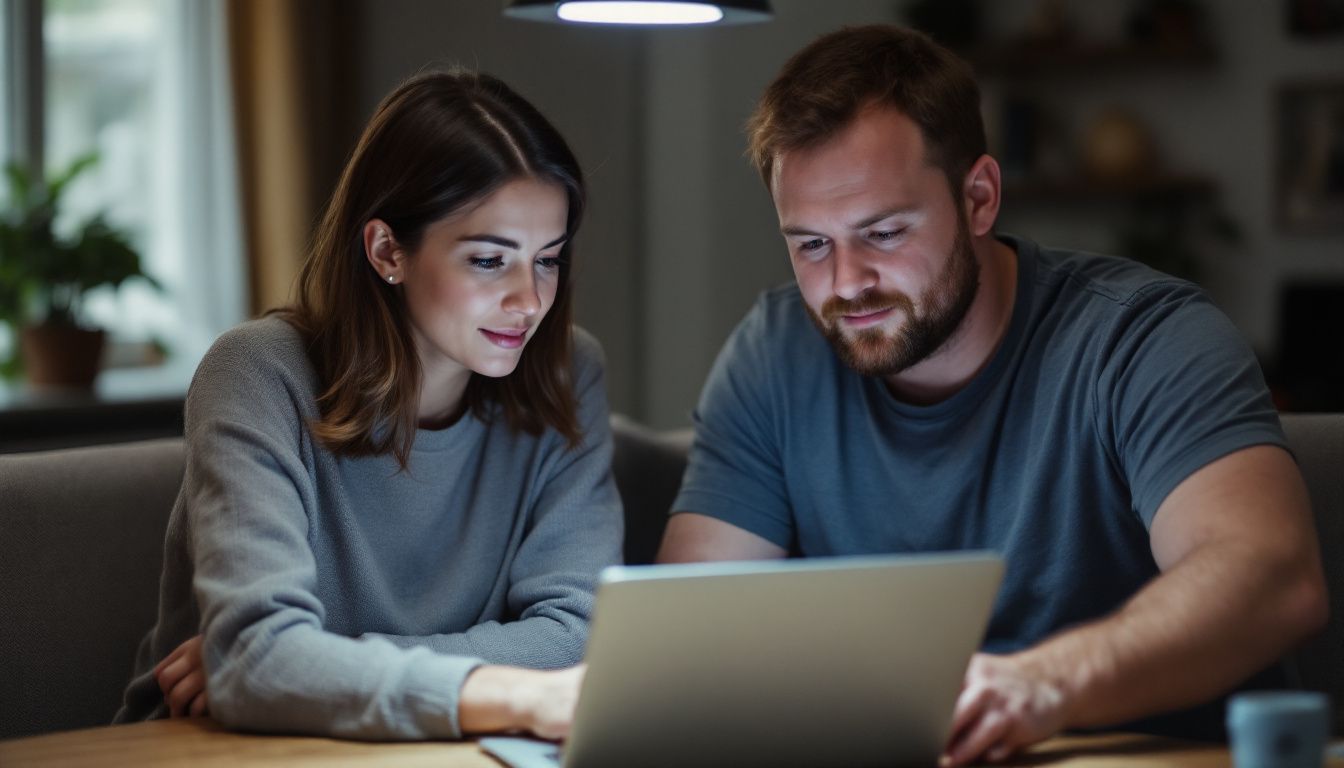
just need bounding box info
[1094,282,1286,526]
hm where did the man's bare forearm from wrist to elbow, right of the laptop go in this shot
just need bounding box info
[1011,542,1324,728]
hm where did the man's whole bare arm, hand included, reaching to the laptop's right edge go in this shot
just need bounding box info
[949,445,1328,764]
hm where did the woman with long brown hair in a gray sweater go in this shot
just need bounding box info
[117,70,621,738]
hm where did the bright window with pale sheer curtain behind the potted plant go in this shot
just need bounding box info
[0,0,245,390]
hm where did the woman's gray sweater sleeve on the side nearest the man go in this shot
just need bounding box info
[364,335,624,668]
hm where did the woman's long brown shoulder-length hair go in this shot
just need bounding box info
[280,69,585,469]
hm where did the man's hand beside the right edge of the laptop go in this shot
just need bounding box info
[942,654,1067,765]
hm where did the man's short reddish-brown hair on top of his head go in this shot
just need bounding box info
[747,24,985,195]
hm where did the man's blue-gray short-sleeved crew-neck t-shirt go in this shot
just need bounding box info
[673,237,1285,736]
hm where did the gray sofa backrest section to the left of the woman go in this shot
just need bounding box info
[0,438,183,738]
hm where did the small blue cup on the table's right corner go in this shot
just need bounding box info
[1227,691,1331,768]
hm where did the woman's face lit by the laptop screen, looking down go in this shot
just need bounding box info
[399,179,569,381]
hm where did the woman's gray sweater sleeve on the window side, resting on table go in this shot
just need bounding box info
[181,332,482,740]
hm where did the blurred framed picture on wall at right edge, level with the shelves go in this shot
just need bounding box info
[1275,81,1344,234]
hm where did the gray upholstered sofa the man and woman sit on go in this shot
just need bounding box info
[0,414,1344,738]
